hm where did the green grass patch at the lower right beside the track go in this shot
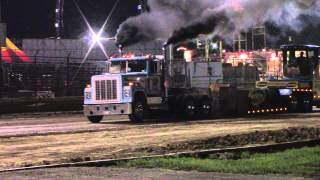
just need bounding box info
[121,146,320,176]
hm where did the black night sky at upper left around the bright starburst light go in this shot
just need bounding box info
[1,0,139,38]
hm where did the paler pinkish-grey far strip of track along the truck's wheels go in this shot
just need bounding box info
[0,113,320,138]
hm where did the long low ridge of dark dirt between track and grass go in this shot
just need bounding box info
[137,128,320,154]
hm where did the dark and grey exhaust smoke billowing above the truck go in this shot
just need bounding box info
[117,0,320,46]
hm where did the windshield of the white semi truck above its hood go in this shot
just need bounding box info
[109,60,147,74]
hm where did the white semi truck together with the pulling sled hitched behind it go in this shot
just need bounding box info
[84,45,320,123]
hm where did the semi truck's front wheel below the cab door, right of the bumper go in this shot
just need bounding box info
[129,100,147,122]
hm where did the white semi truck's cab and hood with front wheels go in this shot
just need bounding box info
[84,55,164,123]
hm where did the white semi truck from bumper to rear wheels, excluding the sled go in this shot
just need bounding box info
[84,50,223,123]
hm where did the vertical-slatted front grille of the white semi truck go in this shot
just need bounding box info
[95,80,118,101]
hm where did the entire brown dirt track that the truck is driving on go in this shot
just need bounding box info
[0,113,320,169]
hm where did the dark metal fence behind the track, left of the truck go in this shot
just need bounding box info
[1,56,106,98]
